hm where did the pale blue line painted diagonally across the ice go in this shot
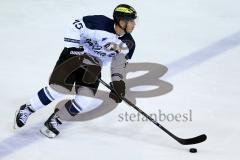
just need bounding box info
[0,32,240,159]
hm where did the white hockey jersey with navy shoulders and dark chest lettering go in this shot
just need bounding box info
[64,15,135,63]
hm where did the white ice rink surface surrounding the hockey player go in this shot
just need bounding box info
[0,0,240,160]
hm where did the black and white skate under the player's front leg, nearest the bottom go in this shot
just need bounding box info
[40,113,62,138]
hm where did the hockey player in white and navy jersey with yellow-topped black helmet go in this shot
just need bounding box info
[14,4,137,138]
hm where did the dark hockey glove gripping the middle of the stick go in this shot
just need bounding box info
[109,80,126,103]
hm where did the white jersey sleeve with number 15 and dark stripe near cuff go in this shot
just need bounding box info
[64,19,86,48]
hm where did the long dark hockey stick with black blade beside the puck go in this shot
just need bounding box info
[81,66,207,145]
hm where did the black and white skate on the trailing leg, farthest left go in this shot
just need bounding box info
[13,104,34,129]
